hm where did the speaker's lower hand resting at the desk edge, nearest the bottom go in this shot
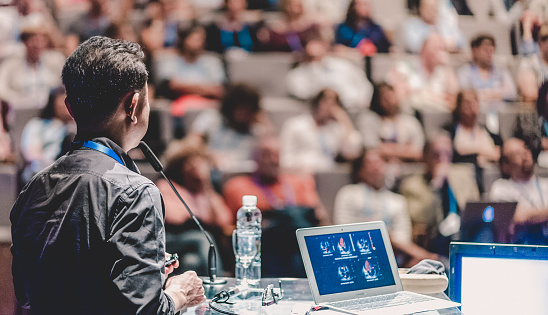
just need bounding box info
[165,271,206,311]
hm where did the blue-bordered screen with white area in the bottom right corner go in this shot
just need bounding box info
[449,242,548,315]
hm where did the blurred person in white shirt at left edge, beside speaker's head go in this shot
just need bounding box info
[0,24,65,108]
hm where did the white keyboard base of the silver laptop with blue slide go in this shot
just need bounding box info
[329,292,433,311]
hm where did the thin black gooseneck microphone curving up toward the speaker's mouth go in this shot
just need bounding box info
[139,141,226,285]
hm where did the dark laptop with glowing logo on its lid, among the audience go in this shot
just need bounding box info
[460,201,518,243]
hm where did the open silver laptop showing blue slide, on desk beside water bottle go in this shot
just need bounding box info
[296,221,459,314]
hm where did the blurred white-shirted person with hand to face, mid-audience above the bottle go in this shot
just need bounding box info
[280,89,362,172]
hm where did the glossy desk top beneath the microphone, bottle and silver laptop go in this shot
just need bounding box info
[183,278,461,315]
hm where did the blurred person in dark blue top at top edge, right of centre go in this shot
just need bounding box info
[335,0,391,53]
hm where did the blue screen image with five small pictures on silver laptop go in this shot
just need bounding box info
[305,230,395,295]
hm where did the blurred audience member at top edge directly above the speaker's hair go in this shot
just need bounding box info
[65,0,112,54]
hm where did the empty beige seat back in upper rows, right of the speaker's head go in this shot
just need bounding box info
[226,52,294,96]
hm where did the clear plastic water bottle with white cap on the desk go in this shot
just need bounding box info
[235,195,263,285]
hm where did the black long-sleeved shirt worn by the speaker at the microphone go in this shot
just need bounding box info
[10,138,174,314]
